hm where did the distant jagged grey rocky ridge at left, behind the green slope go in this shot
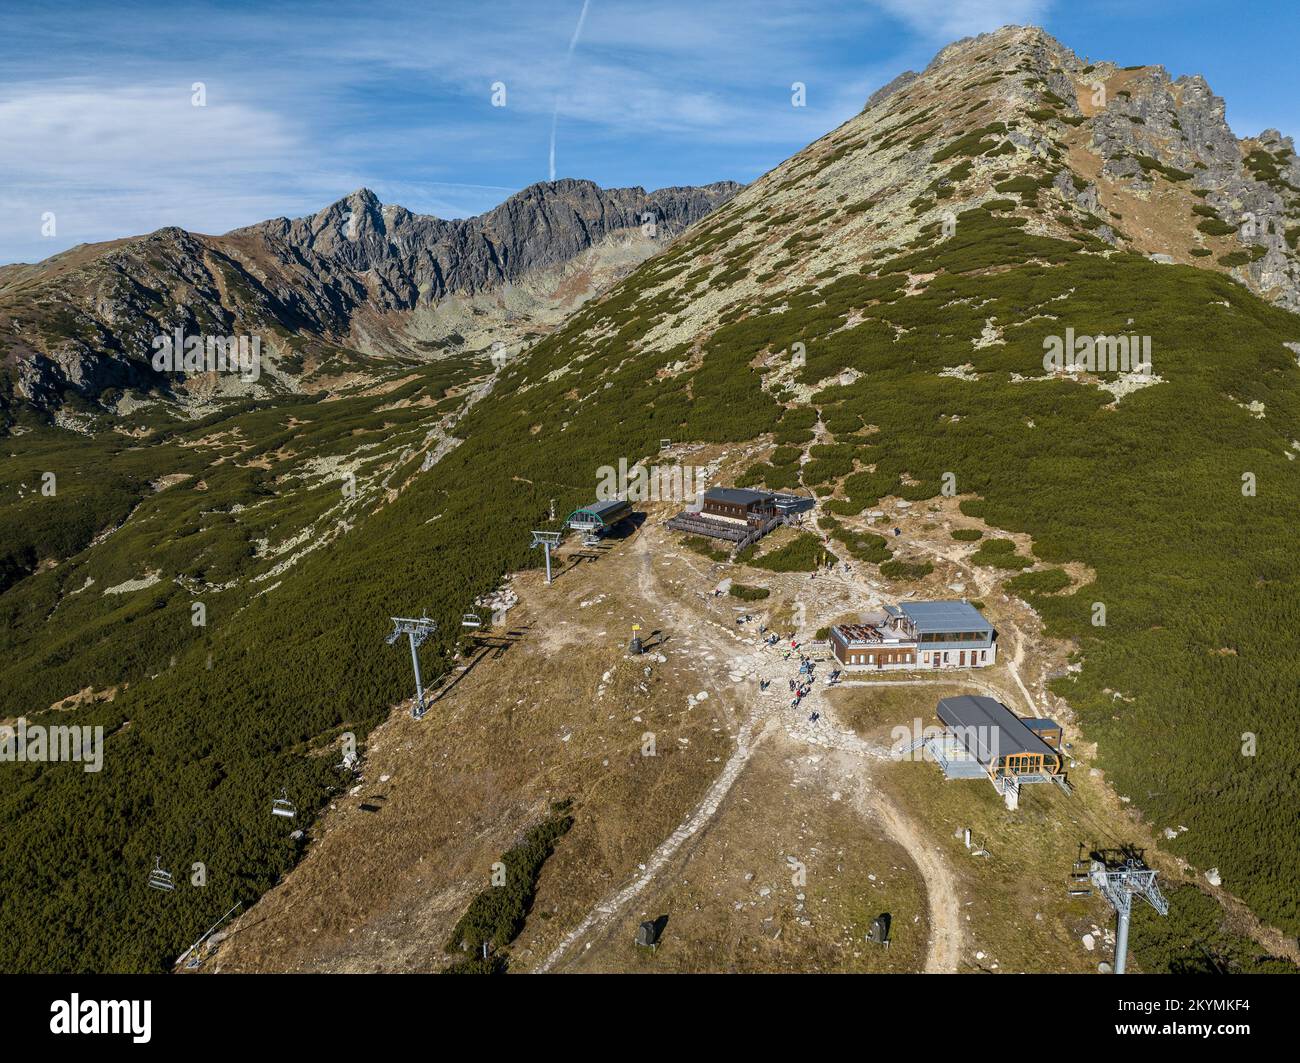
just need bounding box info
[0,179,740,408]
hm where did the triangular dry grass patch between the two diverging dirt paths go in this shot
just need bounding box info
[553,737,928,973]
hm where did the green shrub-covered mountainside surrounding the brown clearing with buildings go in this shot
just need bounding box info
[0,78,1300,969]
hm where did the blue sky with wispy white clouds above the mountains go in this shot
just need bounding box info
[0,0,1300,263]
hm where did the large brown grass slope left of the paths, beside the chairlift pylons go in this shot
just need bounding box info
[220,545,731,971]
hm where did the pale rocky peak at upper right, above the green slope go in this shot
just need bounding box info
[842,26,1300,309]
